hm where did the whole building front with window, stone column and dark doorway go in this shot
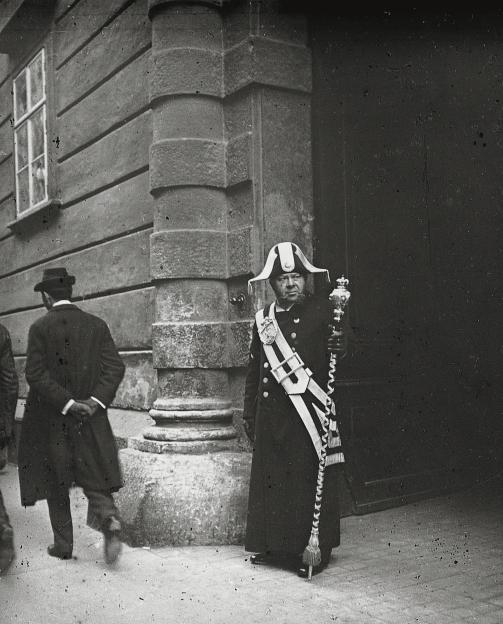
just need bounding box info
[0,0,502,543]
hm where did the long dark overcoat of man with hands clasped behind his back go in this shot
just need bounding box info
[18,304,124,505]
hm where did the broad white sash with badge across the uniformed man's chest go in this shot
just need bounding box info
[255,303,344,466]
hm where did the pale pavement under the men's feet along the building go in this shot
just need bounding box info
[0,465,503,624]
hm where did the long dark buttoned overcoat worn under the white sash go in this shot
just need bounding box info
[243,297,340,555]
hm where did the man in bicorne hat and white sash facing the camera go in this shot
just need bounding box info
[243,242,346,577]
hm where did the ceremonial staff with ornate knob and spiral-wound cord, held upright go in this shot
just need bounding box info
[302,275,351,581]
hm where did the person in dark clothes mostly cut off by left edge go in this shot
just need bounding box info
[0,325,18,573]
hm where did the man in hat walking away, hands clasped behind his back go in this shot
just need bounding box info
[18,268,124,563]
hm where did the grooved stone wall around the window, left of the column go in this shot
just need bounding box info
[0,0,156,436]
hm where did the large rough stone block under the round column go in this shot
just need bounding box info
[115,448,251,546]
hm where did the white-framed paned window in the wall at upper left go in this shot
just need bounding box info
[14,49,48,216]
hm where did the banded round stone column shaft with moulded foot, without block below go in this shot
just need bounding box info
[139,1,236,452]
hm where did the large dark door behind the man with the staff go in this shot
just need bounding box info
[311,13,503,511]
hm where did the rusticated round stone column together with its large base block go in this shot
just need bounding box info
[120,0,251,544]
